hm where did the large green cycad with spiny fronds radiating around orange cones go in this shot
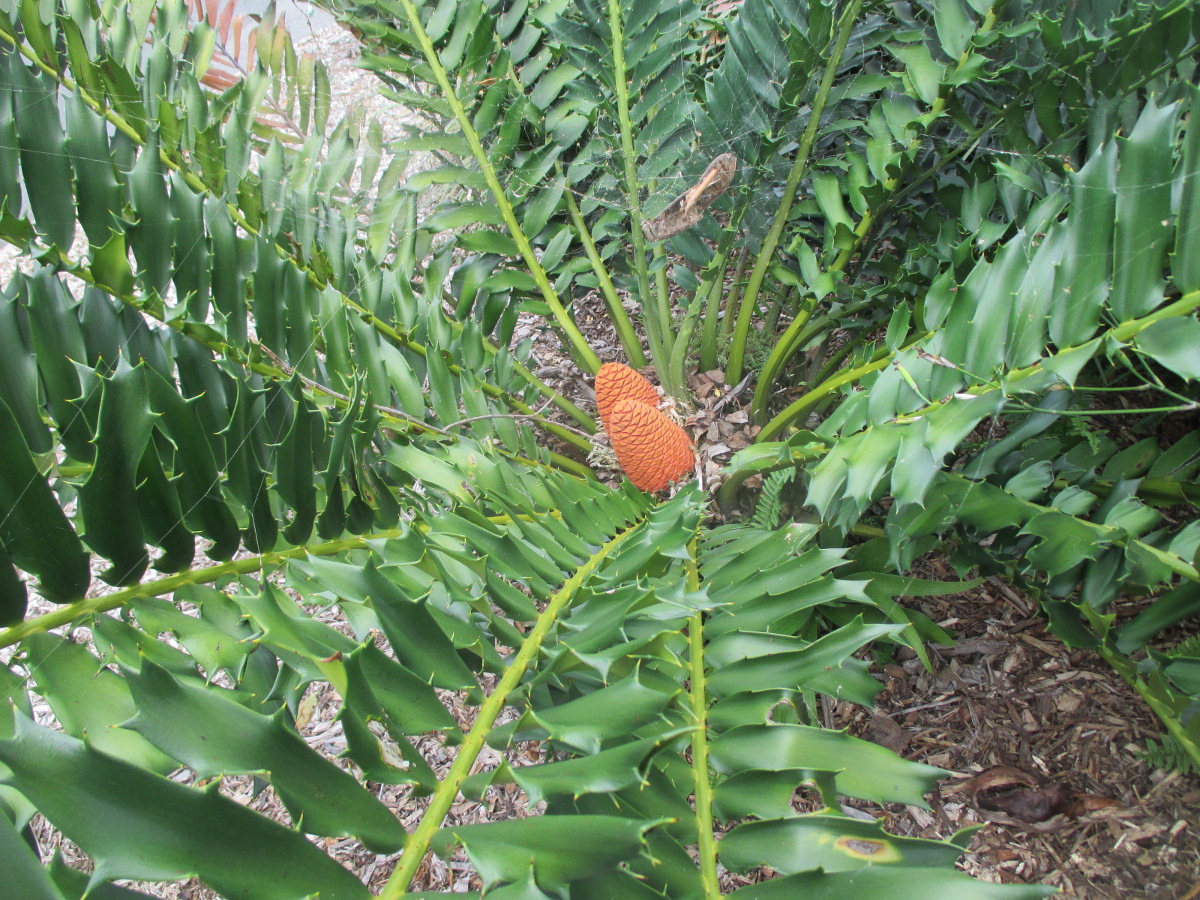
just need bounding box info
[0,0,1200,900]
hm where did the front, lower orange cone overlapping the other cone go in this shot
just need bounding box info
[608,400,696,491]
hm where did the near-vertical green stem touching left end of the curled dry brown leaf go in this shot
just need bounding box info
[608,0,678,388]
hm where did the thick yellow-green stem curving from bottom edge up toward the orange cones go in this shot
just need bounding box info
[379,523,640,900]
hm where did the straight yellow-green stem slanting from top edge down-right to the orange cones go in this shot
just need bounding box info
[400,0,600,373]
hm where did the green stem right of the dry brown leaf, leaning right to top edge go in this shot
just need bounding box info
[726,0,863,384]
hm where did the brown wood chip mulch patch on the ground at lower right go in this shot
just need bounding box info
[836,557,1200,900]
